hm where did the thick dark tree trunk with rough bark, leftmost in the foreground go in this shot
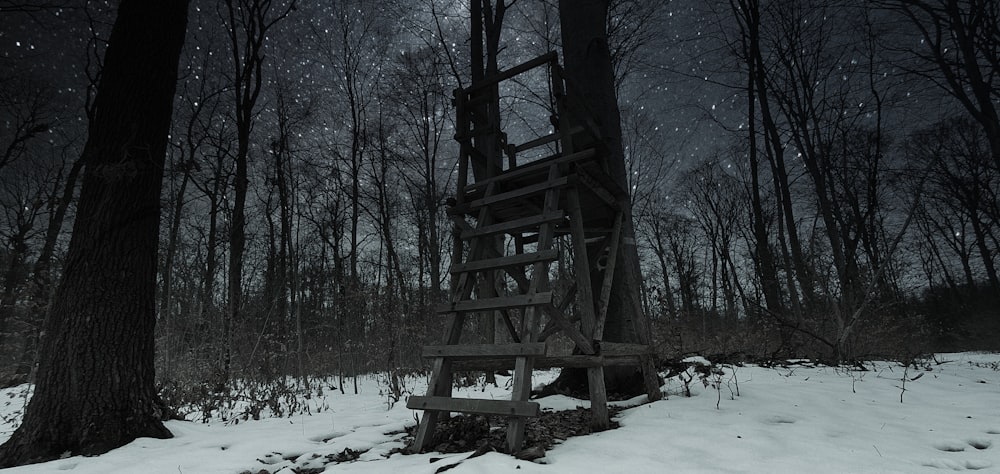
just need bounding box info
[0,0,188,467]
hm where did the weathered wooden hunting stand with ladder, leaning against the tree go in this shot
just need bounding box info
[407,52,659,452]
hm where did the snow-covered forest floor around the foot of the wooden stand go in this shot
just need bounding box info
[0,353,1000,474]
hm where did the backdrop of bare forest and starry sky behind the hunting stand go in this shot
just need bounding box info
[0,0,1000,454]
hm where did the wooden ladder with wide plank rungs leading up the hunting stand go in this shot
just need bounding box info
[407,158,566,451]
